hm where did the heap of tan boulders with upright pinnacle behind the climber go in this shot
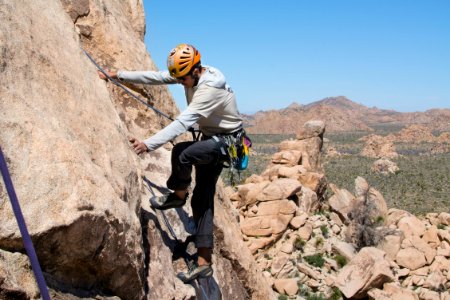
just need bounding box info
[228,121,450,300]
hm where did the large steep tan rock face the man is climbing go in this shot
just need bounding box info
[0,0,270,299]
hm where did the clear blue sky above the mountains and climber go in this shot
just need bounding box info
[144,0,450,113]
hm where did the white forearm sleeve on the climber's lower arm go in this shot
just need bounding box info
[144,108,201,151]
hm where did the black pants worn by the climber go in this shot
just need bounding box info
[167,139,226,248]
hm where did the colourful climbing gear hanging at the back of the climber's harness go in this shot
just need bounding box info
[212,129,252,187]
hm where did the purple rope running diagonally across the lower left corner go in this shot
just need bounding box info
[0,146,50,300]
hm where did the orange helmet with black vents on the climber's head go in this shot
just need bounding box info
[167,44,201,78]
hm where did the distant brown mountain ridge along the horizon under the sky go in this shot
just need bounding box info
[244,96,450,134]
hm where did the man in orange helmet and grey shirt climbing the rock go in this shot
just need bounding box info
[98,44,243,282]
